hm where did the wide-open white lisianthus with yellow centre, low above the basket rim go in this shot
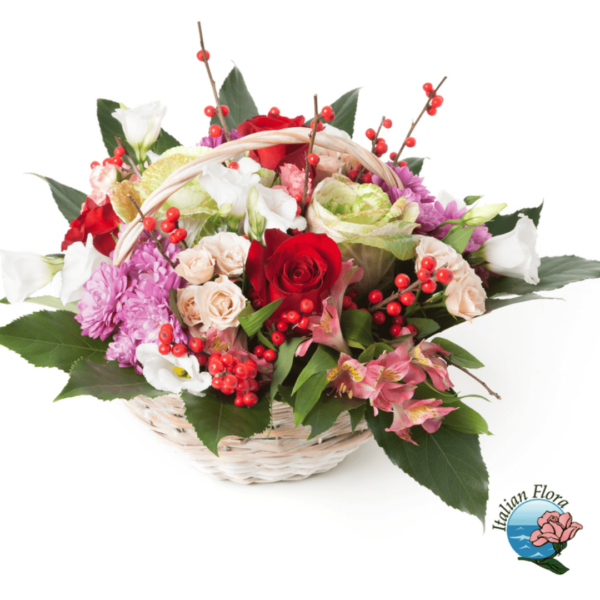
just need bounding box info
[135,344,212,396]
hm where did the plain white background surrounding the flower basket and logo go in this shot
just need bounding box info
[0,0,600,600]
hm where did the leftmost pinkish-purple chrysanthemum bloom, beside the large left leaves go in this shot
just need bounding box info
[75,263,129,341]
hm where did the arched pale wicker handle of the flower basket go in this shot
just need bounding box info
[113,127,404,266]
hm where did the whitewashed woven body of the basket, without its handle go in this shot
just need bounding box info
[125,394,372,484]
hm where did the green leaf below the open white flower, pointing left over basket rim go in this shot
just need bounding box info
[54,360,161,402]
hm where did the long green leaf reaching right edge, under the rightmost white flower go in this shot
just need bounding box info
[488,256,600,297]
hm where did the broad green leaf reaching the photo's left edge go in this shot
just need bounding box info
[0,310,108,373]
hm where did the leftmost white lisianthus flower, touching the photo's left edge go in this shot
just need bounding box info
[0,250,63,304]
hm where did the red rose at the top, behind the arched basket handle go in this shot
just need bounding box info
[237,115,308,171]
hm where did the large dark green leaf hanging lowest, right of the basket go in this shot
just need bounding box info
[367,407,488,527]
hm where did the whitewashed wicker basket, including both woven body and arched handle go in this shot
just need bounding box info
[114,128,403,483]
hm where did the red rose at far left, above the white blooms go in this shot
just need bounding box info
[61,197,120,256]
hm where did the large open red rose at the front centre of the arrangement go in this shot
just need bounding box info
[246,229,342,320]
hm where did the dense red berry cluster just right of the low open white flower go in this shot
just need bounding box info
[208,352,259,407]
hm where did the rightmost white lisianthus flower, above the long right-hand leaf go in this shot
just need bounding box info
[483,215,541,284]
